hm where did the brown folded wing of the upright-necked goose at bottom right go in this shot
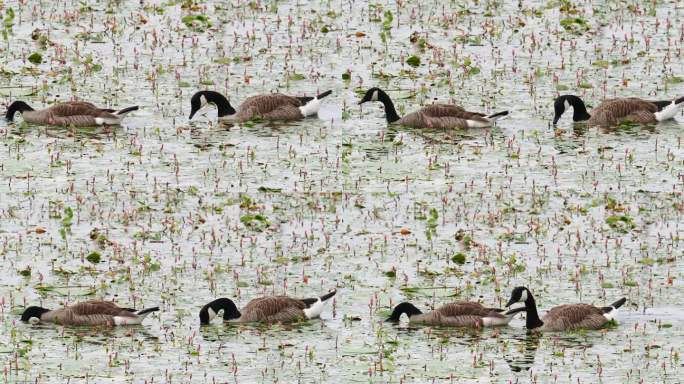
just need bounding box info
[543,304,608,331]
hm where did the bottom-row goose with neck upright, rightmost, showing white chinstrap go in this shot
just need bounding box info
[506,287,627,331]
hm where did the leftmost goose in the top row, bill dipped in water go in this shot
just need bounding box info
[5,101,138,127]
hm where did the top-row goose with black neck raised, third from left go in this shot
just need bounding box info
[359,88,508,129]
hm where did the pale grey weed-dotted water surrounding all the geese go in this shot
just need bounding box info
[0,1,684,383]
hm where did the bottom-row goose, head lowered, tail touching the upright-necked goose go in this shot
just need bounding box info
[386,301,525,328]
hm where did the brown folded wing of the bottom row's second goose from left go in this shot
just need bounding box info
[240,296,306,323]
